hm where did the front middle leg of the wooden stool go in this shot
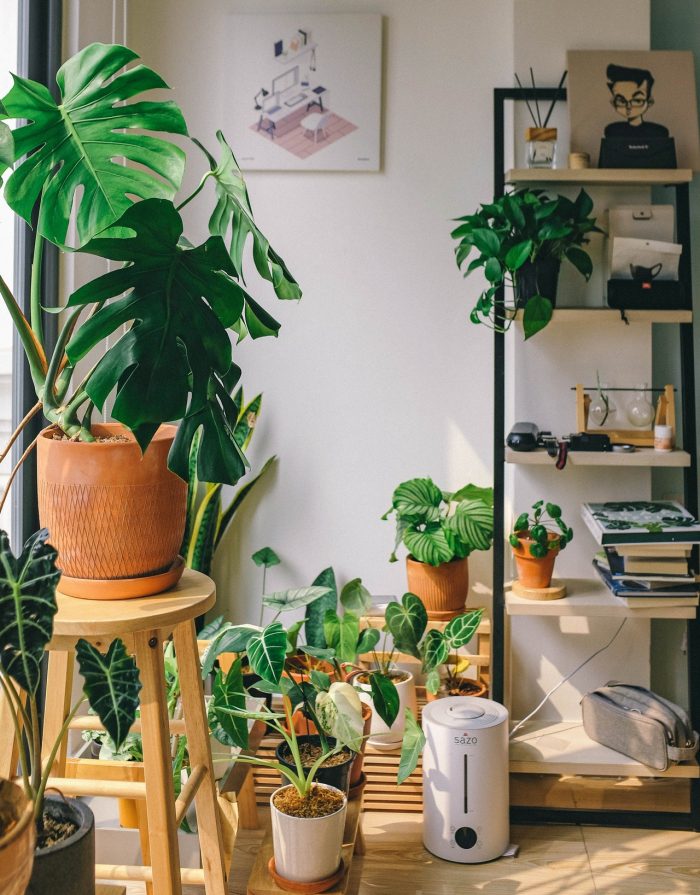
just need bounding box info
[134,631,182,895]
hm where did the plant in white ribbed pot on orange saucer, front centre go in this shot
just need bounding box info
[206,636,362,886]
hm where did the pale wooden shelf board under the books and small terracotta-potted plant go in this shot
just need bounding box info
[505,578,697,618]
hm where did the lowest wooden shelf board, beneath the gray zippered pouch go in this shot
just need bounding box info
[510,721,700,778]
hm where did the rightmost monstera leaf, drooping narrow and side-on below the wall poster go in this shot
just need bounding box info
[194,131,301,306]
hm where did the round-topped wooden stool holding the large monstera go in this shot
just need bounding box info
[8,570,228,895]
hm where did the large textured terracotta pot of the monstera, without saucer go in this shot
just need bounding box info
[37,423,187,592]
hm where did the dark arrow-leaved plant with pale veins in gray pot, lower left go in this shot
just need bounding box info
[0,530,141,895]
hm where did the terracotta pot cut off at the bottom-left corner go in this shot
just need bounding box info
[0,780,36,895]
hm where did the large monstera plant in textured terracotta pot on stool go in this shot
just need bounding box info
[0,43,301,599]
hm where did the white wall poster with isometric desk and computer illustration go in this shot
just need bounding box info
[225,13,382,171]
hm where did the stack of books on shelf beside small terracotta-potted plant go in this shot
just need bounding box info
[582,500,700,609]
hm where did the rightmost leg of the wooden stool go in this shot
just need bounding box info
[173,621,228,895]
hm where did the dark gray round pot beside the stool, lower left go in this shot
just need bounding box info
[26,796,95,895]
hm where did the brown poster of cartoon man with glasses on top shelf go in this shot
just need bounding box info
[567,50,700,171]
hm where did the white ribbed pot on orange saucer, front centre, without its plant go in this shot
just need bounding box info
[270,783,348,883]
